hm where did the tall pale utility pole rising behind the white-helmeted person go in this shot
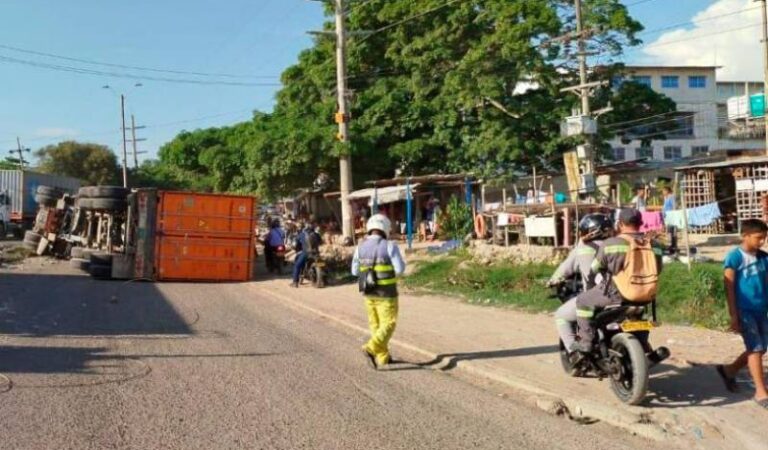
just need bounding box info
[335,0,354,243]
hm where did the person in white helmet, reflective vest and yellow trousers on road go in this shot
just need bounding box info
[352,214,405,369]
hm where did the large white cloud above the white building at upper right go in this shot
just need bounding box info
[642,0,763,81]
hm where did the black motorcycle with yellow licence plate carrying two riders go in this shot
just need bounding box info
[552,277,670,405]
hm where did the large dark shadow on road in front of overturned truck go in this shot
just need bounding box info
[0,273,192,337]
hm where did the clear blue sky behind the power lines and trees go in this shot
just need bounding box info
[0,0,732,165]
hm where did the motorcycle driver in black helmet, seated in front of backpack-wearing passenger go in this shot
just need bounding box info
[547,214,613,353]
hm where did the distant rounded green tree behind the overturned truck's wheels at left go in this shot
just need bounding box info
[35,141,119,185]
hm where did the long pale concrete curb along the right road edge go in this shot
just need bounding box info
[259,290,672,441]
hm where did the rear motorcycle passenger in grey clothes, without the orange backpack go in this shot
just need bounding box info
[571,208,662,353]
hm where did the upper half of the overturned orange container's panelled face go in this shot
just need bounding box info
[157,191,256,239]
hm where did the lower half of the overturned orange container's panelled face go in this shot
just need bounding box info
[155,236,253,281]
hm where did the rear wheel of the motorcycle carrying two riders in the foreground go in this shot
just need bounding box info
[611,333,648,405]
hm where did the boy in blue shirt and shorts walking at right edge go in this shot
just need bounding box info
[716,219,768,409]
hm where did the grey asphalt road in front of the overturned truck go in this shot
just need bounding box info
[0,261,654,449]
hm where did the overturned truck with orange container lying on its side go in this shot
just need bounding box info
[38,186,256,281]
